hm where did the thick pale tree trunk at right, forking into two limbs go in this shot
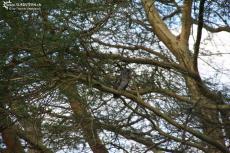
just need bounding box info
[142,0,224,150]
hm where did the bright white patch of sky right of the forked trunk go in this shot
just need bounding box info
[190,26,230,86]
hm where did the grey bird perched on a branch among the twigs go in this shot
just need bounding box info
[113,68,131,98]
